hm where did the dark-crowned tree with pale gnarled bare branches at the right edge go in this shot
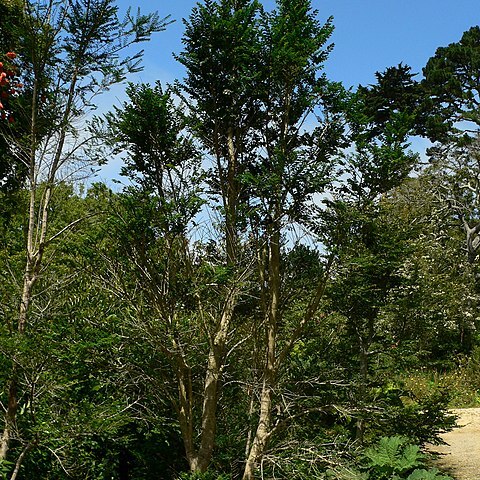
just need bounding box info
[422,26,480,263]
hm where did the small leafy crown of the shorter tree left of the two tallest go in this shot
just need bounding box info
[107,83,203,233]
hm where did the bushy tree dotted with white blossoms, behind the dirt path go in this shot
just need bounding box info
[383,175,478,356]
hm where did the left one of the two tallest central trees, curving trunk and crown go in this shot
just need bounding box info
[173,0,261,471]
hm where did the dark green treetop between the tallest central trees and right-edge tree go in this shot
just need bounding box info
[340,64,423,202]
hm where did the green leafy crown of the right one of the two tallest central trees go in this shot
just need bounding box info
[244,0,345,223]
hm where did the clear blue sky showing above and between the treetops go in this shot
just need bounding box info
[94,0,480,181]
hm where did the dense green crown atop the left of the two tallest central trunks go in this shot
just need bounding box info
[176,0,262,143]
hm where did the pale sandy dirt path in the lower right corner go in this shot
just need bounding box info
[430,408,480,480]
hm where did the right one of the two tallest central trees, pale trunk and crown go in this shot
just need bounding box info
[243,0,342,480]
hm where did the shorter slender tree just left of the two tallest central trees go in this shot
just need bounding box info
[102,84,213,471]
